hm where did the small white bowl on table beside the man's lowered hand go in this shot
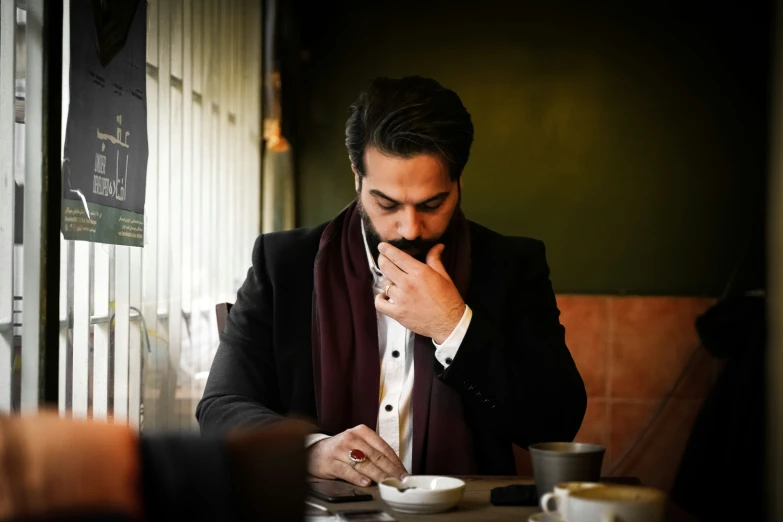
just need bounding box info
[378,475,465,515]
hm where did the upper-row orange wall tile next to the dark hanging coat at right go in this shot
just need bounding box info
[609,297,713,399]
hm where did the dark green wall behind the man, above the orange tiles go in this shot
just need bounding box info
[295,1,767,295]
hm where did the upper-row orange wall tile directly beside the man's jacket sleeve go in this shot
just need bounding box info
[557,295,610,398]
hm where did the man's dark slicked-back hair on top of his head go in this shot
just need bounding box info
[345,76,473,180]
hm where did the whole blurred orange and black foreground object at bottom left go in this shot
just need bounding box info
[0,413,308,520]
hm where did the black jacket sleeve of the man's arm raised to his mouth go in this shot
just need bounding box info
[436,241,587,448]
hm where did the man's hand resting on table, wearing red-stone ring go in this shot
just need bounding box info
[307,425,408,486]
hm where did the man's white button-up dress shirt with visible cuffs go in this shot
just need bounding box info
[305,227,473,473]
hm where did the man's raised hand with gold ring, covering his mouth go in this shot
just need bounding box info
[375,243,465,344]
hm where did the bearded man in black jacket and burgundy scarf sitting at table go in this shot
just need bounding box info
[196,77,586,485]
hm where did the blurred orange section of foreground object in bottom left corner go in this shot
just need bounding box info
[0,413,141,520]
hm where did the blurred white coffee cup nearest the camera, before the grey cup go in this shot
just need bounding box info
[564,485,666,522]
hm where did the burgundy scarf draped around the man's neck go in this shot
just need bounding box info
[312,198,475,475]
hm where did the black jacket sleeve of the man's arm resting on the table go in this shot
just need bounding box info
[196,236,283,434]
